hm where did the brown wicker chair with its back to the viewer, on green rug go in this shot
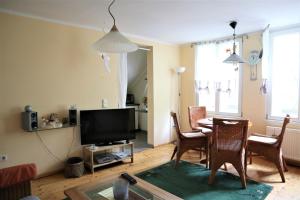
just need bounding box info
[208,118,248,188]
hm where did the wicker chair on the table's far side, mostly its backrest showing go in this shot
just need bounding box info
[188,106,207,130]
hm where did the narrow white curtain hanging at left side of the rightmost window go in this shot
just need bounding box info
[260,25,270,94]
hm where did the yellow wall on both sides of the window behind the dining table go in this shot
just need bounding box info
[180,33,266,133]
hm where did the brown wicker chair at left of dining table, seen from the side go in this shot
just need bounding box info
[171,112,212,167]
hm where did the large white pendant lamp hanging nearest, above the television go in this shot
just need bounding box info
[93,0,138,53]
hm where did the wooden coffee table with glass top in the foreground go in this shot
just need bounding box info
[64,175,182,200]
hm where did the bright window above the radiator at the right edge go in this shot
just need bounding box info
[268,29,300,119]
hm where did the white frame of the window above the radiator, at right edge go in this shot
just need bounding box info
[266,27,300,123]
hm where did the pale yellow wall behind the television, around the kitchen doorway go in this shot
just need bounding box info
[0,13,180,175]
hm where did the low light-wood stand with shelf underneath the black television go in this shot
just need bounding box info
[83,142,133,174]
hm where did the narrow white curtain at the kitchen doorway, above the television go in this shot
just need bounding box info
[118,53,128,108]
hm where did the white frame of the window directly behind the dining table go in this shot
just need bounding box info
[195,38,243,117]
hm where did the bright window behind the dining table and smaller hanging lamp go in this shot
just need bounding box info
[195,41,241,116]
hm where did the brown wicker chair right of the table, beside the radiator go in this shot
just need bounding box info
[245,115,290,182]
